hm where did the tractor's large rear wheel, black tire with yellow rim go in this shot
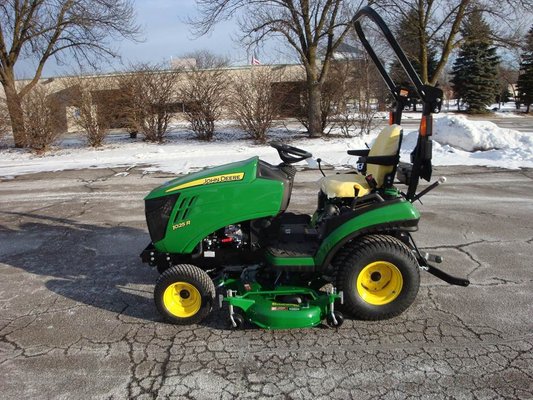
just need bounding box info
[333,235,420,320]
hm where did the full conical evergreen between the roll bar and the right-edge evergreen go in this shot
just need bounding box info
[452,12,500,113]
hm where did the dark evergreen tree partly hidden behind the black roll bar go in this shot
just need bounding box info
[390,10,437,111]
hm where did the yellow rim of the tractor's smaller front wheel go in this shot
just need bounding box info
[163,282,202,318]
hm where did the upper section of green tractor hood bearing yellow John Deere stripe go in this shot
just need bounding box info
[145,157,259,200]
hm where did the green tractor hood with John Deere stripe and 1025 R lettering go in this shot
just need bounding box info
[145,157,286,254]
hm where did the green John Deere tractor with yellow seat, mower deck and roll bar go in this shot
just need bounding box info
[141,7,469,329]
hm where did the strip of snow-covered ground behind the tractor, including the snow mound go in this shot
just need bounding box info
[0,115,533,177]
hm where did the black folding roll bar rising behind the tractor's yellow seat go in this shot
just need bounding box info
[352,6,443,201]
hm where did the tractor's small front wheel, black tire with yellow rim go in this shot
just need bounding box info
[154,264,215,325]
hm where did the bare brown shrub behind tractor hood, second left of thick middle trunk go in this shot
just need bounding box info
[179,51,229,141]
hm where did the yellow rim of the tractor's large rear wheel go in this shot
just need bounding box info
[357,261,403,306]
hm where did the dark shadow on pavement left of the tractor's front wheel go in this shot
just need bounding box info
[0,212,161,321]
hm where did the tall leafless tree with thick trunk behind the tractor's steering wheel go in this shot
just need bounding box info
[192,0,362,137]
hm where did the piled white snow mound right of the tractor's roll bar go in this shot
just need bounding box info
[433,115,533,154]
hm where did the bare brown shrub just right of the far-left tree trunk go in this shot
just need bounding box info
[22,85,60,154]
